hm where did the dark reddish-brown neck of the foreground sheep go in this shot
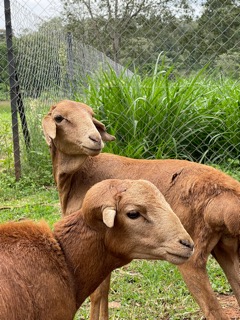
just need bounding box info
[54,211,129,308]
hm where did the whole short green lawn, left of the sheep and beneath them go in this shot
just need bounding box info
[0,102,233,320]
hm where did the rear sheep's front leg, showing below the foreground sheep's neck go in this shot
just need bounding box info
[90,274,111,320]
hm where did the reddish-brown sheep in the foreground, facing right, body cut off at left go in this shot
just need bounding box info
[0,179,193,320]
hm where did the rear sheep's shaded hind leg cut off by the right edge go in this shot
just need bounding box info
[213,238,240,305]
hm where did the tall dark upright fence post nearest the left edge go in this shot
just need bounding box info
[4,0,21,181]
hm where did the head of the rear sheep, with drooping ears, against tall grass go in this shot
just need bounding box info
[42,100,115,156]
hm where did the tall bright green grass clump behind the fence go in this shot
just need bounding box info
[76,66,240,165]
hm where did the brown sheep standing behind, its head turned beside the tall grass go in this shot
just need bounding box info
[42,100,240,320]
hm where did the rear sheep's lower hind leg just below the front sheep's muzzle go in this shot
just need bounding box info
[178,260,229,320]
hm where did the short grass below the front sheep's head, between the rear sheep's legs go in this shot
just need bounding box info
[76,258,230,320]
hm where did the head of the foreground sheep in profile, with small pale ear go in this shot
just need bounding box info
[82,179,193,264]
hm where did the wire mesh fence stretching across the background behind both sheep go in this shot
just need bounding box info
[0,0,240,180]
